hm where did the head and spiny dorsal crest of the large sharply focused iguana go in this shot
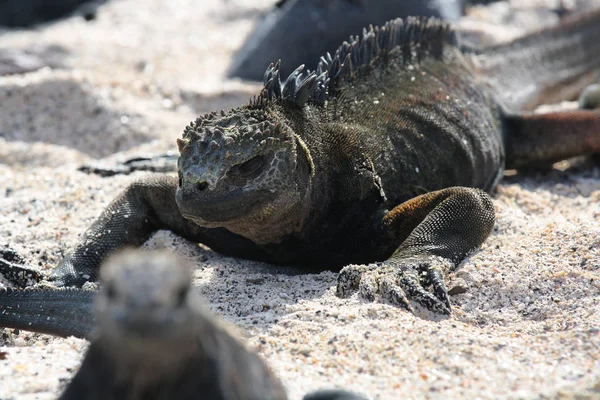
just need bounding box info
[176,18,453,244]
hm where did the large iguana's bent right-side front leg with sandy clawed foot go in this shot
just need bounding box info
[337,187,495,314]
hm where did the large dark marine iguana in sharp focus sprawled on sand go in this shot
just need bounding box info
[0,10,600,330]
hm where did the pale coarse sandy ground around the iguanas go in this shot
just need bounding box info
[0,0,600,400]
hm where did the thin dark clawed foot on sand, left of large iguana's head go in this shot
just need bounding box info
[77,151,179,177]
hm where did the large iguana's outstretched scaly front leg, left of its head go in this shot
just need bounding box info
[50,176,260,286]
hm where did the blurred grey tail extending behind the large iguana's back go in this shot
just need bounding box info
[473,9,600,112]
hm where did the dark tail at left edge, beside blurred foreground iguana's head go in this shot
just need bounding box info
[0,289,95,338]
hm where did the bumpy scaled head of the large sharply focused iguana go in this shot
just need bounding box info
[176,106,314,243]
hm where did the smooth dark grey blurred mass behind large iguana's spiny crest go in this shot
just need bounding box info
[227,0,465,81]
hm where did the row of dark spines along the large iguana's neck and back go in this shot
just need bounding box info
[250,17,456,108]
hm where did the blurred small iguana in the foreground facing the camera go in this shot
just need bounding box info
[48,250,365,400]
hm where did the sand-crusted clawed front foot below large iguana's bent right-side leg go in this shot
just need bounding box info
[337,256,453,315]
